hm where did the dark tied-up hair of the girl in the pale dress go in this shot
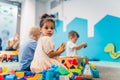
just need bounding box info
[39,13,55,27]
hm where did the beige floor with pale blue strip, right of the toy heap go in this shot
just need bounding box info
[89,61,120,80]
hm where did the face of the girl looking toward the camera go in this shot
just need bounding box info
[41,21,54,36]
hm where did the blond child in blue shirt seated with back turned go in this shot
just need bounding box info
[19,27,40,71]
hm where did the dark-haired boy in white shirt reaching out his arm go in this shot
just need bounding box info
[66,31,87,56]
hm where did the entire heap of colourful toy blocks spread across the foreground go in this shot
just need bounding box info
[0,56,99,80]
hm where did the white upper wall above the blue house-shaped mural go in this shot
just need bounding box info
[47,0,120,37]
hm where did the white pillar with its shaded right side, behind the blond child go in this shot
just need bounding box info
[20,0,46,45]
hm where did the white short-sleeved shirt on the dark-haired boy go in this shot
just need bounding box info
[66,41,78,56]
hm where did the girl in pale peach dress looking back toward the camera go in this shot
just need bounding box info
[30,14,65,72]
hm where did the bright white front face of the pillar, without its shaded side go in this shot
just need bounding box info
[20,0,35,44]
